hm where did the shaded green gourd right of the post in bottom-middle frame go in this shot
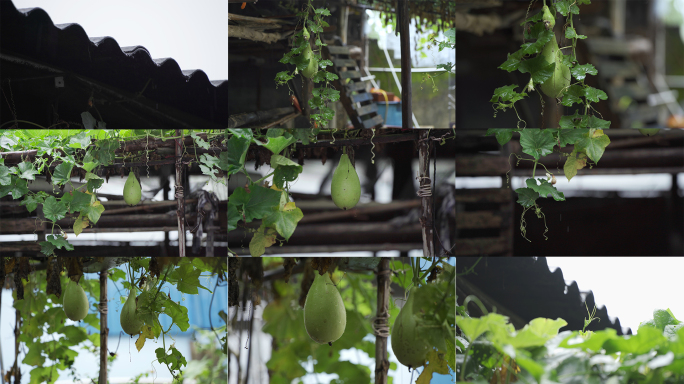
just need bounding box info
[391,287,429,369]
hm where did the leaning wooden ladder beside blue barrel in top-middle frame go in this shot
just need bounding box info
[322,45,384,129]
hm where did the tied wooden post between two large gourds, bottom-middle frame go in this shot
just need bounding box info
[373,257,391,384]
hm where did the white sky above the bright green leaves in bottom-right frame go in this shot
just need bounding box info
[546,257,684,333]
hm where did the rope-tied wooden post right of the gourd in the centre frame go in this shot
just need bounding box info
[418,130,436,257]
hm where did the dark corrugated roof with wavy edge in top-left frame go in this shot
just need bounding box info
[0,0,228,127]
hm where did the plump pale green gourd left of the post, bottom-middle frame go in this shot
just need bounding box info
[304,273,347,346]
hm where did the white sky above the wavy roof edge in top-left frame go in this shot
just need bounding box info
[13,0,228,80]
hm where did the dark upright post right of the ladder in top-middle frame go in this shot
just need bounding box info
[397,0,413,128]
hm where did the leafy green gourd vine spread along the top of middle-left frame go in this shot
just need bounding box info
[0,128,228,256]
